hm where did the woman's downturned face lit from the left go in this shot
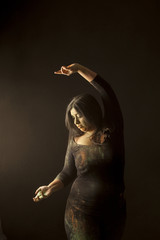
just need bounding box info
[70,108,93,132]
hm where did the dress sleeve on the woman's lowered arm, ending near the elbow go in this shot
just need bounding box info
[56,141,77,186]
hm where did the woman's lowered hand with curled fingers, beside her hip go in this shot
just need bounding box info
[33,186,52,202]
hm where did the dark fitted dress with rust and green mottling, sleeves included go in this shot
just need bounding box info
[56,75,126,240]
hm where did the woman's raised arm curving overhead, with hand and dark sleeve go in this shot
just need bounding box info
[55,63,123,131]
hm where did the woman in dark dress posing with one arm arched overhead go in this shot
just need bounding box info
[33,63,126,240]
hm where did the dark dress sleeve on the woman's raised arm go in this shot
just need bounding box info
[90,75,123,131]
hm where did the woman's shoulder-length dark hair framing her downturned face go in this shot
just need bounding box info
[65,93,103,142]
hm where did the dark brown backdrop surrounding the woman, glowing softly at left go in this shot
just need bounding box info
[0,0,160,240]
